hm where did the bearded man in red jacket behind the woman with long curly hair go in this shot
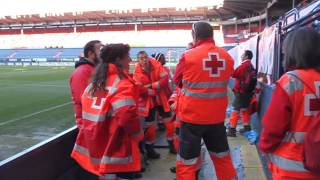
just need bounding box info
[69,40,102,127]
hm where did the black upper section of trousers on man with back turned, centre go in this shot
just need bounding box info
[179,122,229,160]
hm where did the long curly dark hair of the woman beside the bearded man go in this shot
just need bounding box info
[90,44,130,94]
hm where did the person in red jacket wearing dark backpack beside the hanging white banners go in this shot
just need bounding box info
[227,50,256,137]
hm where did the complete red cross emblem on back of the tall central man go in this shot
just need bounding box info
[203,53,226,77]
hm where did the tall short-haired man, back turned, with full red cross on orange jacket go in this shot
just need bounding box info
[174,22,236,180]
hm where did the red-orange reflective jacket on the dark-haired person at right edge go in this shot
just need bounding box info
[259,69,320,180]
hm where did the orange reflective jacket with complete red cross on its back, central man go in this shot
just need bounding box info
[177,40,233,124]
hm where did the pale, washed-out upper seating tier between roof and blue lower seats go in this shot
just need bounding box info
[0,24,263,48]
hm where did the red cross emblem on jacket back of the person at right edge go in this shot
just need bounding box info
[304,81,320,116]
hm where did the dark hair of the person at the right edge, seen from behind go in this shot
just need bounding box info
[282,28,320,69]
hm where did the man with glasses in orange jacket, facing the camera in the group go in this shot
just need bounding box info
[133,51,173,159]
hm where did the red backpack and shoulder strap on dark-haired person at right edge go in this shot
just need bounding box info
[288,73,320,174]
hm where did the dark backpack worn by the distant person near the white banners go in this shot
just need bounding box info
[240,66,257,93]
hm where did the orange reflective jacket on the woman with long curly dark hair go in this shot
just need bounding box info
[71,64,143,175]
